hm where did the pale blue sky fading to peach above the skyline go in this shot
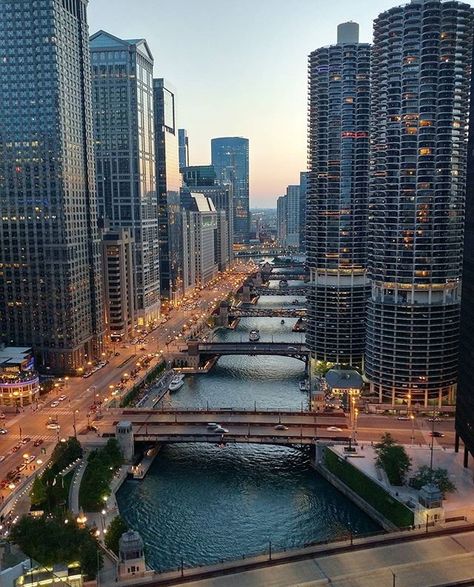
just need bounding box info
[89,0,474,208]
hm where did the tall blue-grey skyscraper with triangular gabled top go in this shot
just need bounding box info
[90,31,160,326]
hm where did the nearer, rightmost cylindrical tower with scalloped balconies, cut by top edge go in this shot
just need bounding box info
[366,0,473,405]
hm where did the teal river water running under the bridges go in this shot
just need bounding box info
[117,282,379,571]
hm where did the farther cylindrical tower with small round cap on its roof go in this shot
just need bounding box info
[306,23,370,365]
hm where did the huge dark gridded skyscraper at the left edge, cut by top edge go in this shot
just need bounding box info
[0,0,104,373]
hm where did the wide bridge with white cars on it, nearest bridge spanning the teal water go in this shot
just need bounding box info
[103,409,350,445]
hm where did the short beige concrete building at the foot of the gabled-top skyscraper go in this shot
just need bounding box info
[102,228,136,344]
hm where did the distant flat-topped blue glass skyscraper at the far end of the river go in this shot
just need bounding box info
[211,137,250,243]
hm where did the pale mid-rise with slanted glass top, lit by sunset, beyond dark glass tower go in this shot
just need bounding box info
[181,190,218,289]
